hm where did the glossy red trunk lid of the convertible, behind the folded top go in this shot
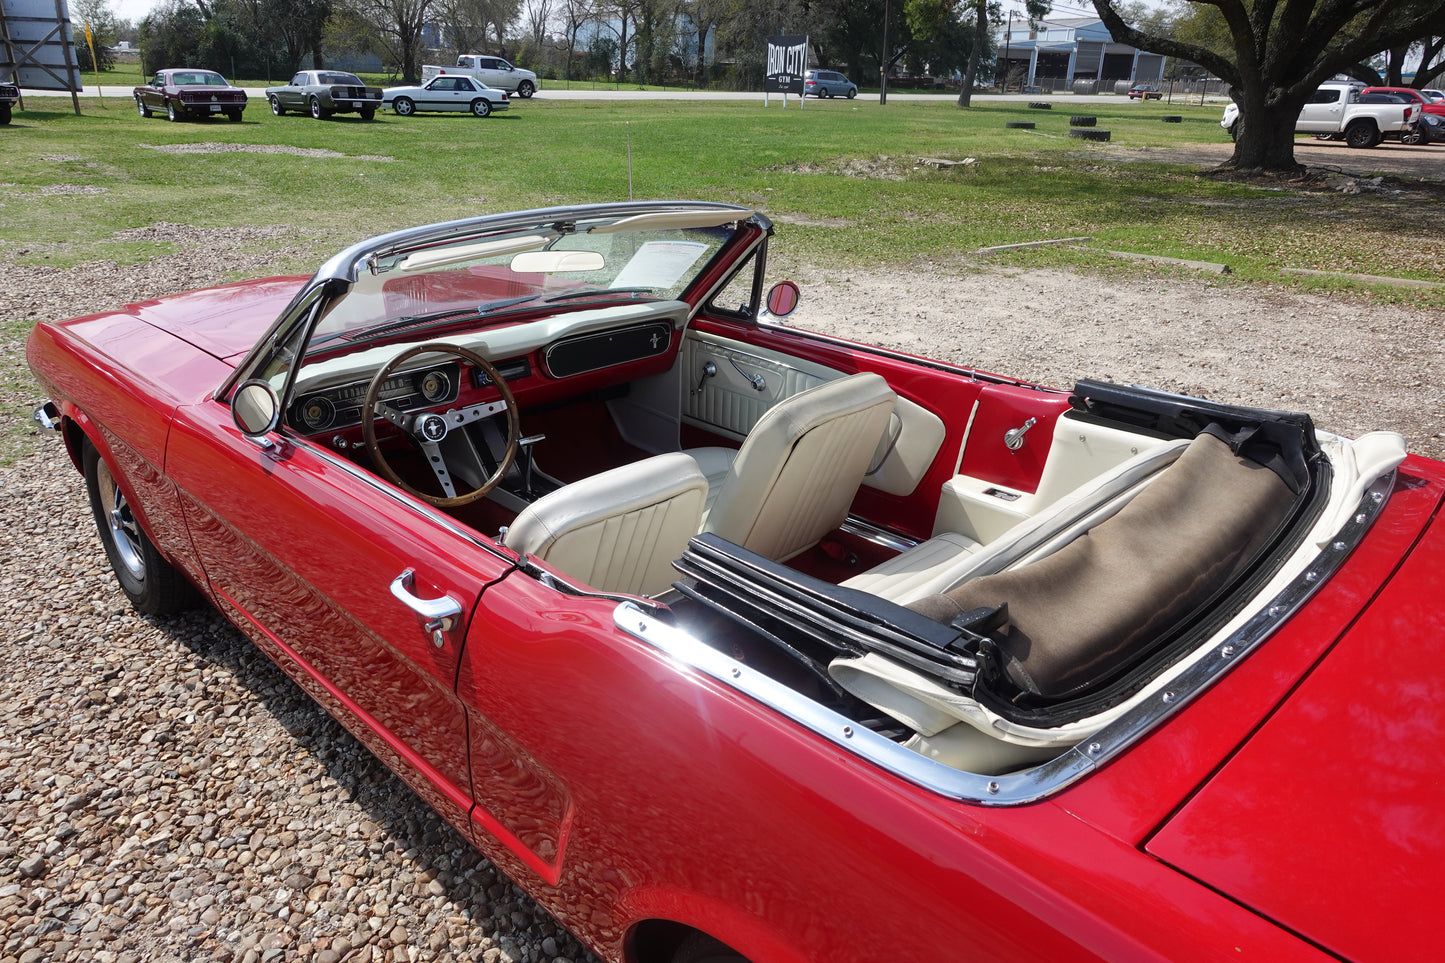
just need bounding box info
[1147,488,1445,962]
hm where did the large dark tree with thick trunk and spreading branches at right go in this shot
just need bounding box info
[1092,0,1445,174]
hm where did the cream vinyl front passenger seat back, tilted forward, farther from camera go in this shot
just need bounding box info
[702,373,897,561]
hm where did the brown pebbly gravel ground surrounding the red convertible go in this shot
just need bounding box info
[0,226,1445,963]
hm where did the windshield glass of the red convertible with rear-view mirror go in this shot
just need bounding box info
[306,210,738,354]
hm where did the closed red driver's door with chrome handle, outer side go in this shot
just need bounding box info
[166,402,510,827]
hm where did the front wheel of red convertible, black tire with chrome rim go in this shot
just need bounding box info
[82,441,195,616]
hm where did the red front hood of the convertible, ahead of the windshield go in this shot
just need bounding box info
[124,278,306,363]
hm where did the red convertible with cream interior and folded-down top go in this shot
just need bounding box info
[27,202,1445,963]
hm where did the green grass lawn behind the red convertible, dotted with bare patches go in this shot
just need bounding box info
[0,91,1445,296]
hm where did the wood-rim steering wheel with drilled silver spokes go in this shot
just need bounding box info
[361,341,522,508]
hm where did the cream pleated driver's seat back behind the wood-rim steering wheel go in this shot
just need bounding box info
[503,453,708,594]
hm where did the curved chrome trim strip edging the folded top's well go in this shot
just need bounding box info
[613,471,1394,807]
